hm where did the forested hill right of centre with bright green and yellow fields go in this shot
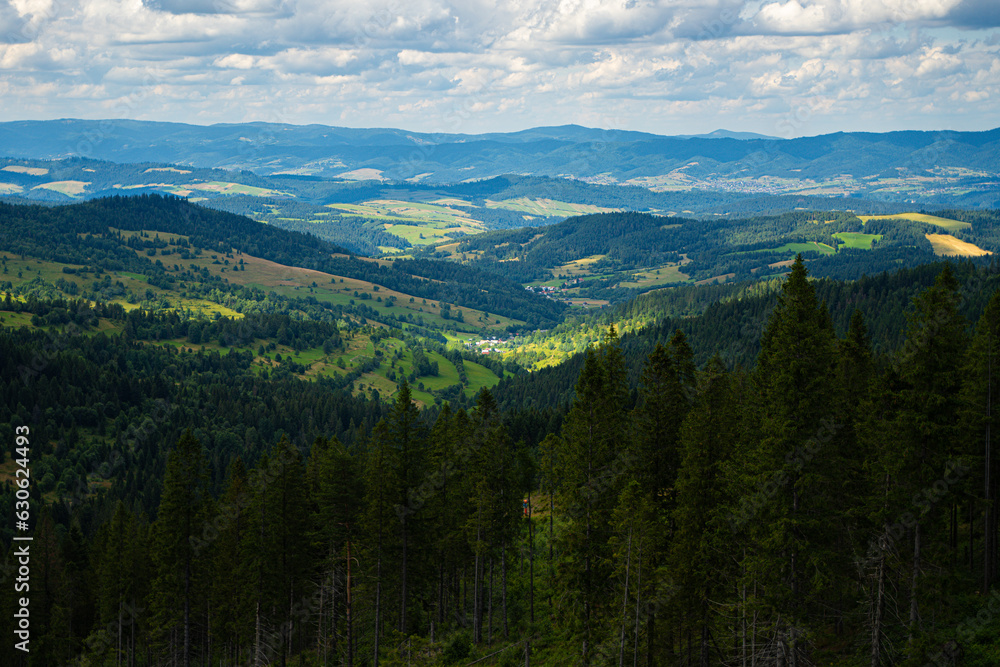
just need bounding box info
[444,210,1000,301]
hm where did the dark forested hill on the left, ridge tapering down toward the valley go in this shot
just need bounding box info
[0,195,565,325]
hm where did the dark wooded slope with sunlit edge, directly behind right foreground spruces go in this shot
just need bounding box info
[495,260,1000,411]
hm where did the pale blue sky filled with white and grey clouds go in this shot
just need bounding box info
[0,0,1000,138]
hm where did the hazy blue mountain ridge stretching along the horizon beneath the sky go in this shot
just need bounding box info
[0,119,1000,207]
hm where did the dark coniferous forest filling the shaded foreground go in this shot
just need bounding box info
[0,252,1000,667]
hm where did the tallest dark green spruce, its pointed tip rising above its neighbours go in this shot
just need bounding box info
[742,255,837,667]
